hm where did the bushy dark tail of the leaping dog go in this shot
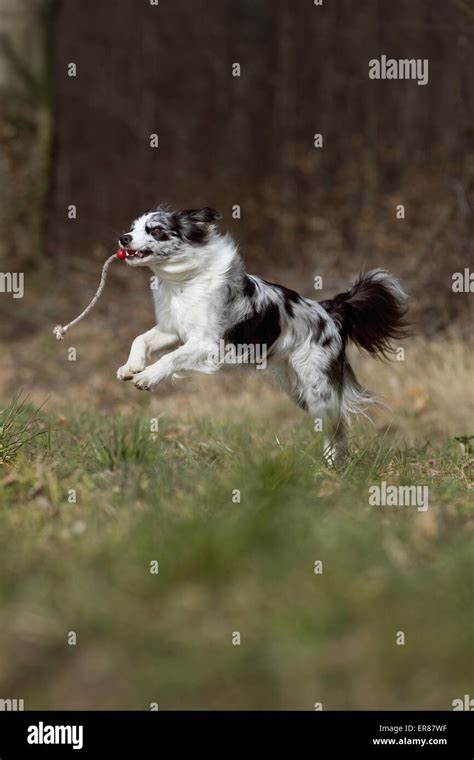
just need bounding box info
[322,269,409,357]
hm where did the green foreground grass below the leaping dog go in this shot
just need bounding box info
[0,401,474,710]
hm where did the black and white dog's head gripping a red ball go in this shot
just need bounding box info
[119,206,221,267]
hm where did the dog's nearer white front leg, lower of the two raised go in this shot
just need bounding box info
[133,338,219,391]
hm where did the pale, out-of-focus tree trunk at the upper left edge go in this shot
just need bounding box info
[0,0,59,269]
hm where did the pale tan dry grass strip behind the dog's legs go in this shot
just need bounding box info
[0,324,474,443]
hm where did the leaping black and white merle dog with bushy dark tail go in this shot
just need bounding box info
[117,206,407,463]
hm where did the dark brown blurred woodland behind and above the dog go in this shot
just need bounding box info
[0,0,474,335]
